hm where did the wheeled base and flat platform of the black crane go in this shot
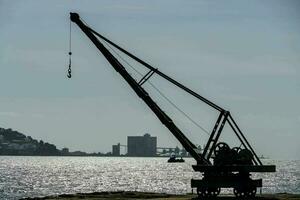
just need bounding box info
[191,165,275,198]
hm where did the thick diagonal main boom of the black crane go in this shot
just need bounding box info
[70,13,211,165]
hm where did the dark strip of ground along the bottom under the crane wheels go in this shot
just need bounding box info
[22,191,300,200]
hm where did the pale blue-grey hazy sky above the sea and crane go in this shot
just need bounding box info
[0,0,300,159]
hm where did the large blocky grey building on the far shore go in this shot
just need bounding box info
[127,133,157,156]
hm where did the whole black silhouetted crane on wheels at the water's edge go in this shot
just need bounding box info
[69,13,275,197]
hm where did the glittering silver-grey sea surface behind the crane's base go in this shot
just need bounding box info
[0,156,300,199]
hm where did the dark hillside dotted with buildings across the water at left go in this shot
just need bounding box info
[0,128,61,156]
